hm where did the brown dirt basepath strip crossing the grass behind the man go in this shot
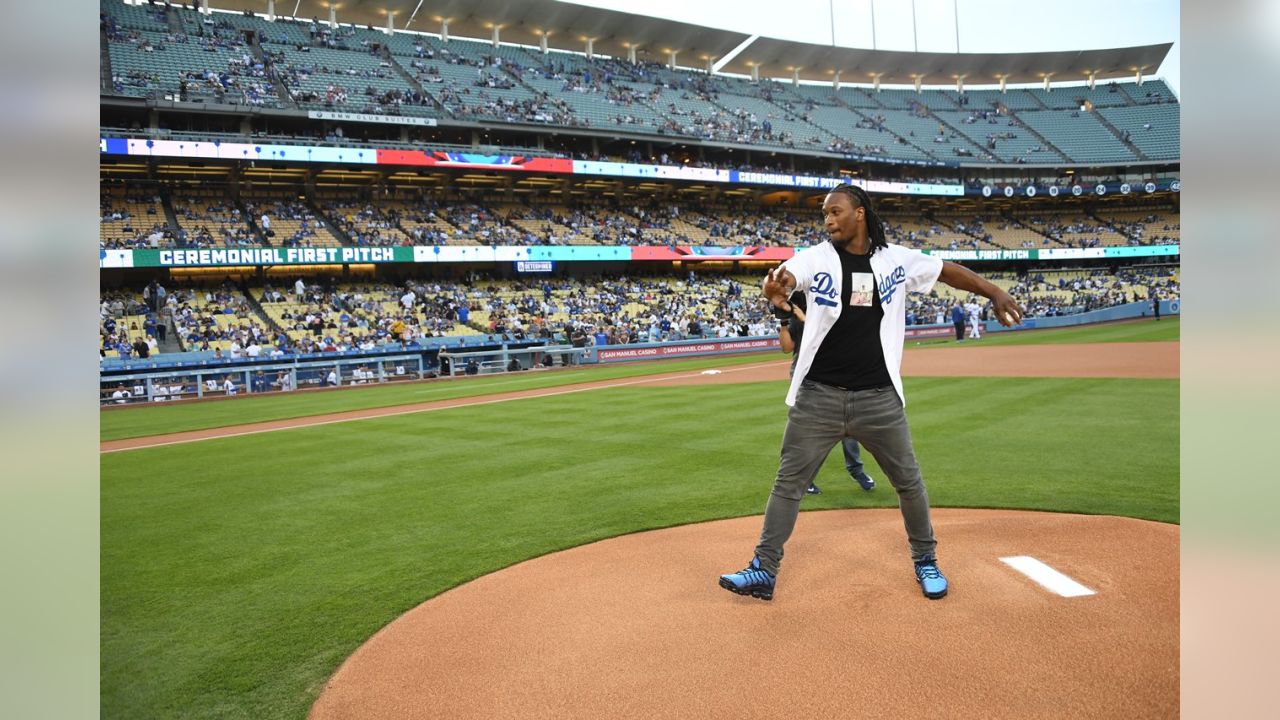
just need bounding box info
[99,342,1178,452]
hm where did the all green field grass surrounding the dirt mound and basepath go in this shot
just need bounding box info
[101,319,1179,719]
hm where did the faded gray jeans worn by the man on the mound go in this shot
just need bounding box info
[755,380,938,574]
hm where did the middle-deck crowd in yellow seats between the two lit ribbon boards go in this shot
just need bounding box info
[100,180,1180,250]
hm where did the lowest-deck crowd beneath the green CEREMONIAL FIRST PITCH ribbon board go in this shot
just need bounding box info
[100,256,1180,368]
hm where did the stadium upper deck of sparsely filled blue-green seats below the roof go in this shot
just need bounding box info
[101,0,1180,167]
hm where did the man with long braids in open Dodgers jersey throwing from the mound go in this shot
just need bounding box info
[719,184,1023,600]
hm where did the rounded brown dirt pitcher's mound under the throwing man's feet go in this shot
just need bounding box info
[311,507,1179,720]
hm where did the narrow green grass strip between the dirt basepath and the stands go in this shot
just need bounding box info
[100,318,1178,441]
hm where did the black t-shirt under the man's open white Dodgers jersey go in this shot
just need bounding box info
[805,247,892,389]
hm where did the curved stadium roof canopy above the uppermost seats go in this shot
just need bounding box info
[210,0,1172,86]
